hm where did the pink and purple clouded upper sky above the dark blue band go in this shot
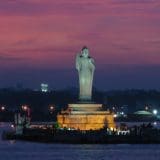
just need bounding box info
[0,0,160,68]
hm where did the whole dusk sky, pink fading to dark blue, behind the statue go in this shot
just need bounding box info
[0,0,160,90]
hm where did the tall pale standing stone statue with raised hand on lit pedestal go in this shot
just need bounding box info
[76,47,95,101]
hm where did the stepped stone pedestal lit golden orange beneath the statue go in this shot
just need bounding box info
[57,103,115,130]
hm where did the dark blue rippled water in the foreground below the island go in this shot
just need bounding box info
[0,124,160,160]
